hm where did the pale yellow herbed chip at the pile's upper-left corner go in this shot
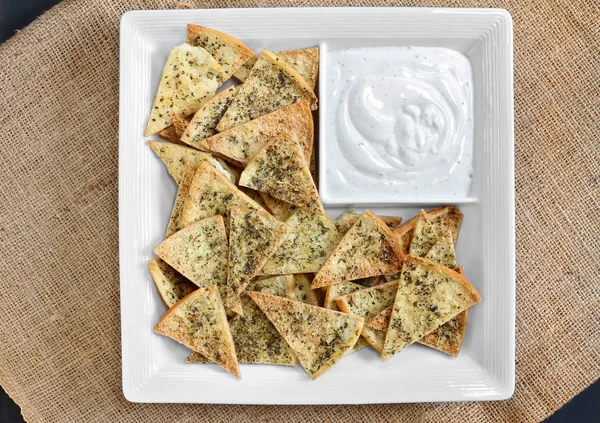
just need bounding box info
[144,43,222,136]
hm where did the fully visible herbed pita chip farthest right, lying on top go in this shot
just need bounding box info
[381,256,481,360]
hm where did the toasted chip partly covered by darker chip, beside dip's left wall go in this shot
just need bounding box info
[198,100,314,164]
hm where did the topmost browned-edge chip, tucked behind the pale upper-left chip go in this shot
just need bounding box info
[188,24,254,85]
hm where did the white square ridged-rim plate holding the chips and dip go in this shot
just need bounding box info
[119,8,515,404]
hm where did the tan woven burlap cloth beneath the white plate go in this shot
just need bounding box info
[0,0,600,422]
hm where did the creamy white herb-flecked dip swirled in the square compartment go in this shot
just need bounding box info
[324,47,473,200]
